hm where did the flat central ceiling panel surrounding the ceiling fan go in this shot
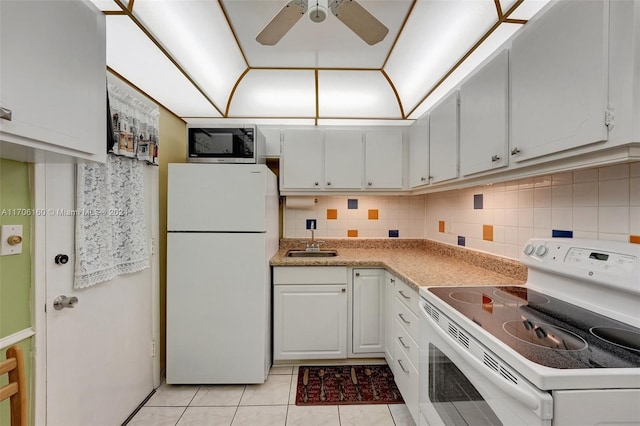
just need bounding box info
[220,0,413,69]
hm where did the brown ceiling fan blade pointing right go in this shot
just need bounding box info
[331,0,389,45]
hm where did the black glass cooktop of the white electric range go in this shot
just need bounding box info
[428,286,640,369]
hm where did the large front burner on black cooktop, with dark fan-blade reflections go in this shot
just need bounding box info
[502,318,587,351]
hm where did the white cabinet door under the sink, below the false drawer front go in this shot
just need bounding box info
[273,284,347,360]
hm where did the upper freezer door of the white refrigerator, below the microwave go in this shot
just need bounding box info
[167,164,276,232]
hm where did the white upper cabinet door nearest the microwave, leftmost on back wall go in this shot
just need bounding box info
[282,129,322,189]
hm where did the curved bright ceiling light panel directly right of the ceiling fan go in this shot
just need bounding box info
[385,0,498,115]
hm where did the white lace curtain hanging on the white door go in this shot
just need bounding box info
[74,155,149,289]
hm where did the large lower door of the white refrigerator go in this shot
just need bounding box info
[167,233,271,384]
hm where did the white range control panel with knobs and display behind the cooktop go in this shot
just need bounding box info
[520,238,640,288]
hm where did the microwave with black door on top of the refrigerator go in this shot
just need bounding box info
[187,126,265,164]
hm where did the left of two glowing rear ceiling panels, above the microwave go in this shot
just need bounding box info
[228,70,316,118]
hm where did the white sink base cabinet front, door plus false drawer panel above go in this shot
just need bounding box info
[273,266,347,361]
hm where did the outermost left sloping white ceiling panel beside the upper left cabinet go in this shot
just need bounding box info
[106,15,220,117]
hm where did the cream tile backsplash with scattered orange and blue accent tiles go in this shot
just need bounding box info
[284,162,640,259]
